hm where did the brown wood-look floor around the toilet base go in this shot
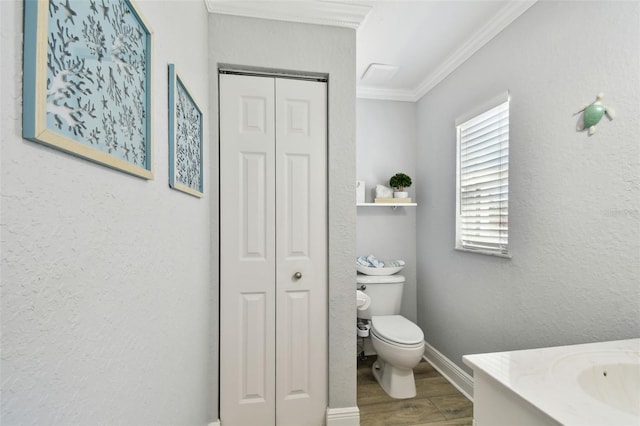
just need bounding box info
[358,355,473,426]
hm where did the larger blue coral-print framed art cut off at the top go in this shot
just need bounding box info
[22,0,153,179]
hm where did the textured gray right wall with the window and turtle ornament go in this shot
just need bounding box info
[417,1,640,371]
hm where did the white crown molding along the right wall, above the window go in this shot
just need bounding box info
[414,0,538,102]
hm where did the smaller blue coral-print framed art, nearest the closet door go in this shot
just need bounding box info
[169,64,204,197]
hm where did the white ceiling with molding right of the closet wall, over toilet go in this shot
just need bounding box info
[356,0,533,101]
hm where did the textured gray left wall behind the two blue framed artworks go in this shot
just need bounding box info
[0,0,215,425]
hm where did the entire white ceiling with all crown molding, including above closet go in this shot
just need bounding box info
[205,0,536,101]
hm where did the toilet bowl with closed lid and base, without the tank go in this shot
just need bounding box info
[370,315,424,399]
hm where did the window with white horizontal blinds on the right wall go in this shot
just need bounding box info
[456,93,509,257]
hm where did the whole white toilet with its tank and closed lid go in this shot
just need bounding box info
[356,274,424,398]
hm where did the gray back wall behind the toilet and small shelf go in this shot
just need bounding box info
[356,99,420,321]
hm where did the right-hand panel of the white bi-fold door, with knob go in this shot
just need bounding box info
[276,79,328,426]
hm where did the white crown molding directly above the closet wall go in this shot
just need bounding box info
[205,0,371,29]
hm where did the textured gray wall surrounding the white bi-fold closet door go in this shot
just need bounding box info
[209,14,356,416]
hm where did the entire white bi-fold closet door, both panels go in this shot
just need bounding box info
[219,74,328,426]
